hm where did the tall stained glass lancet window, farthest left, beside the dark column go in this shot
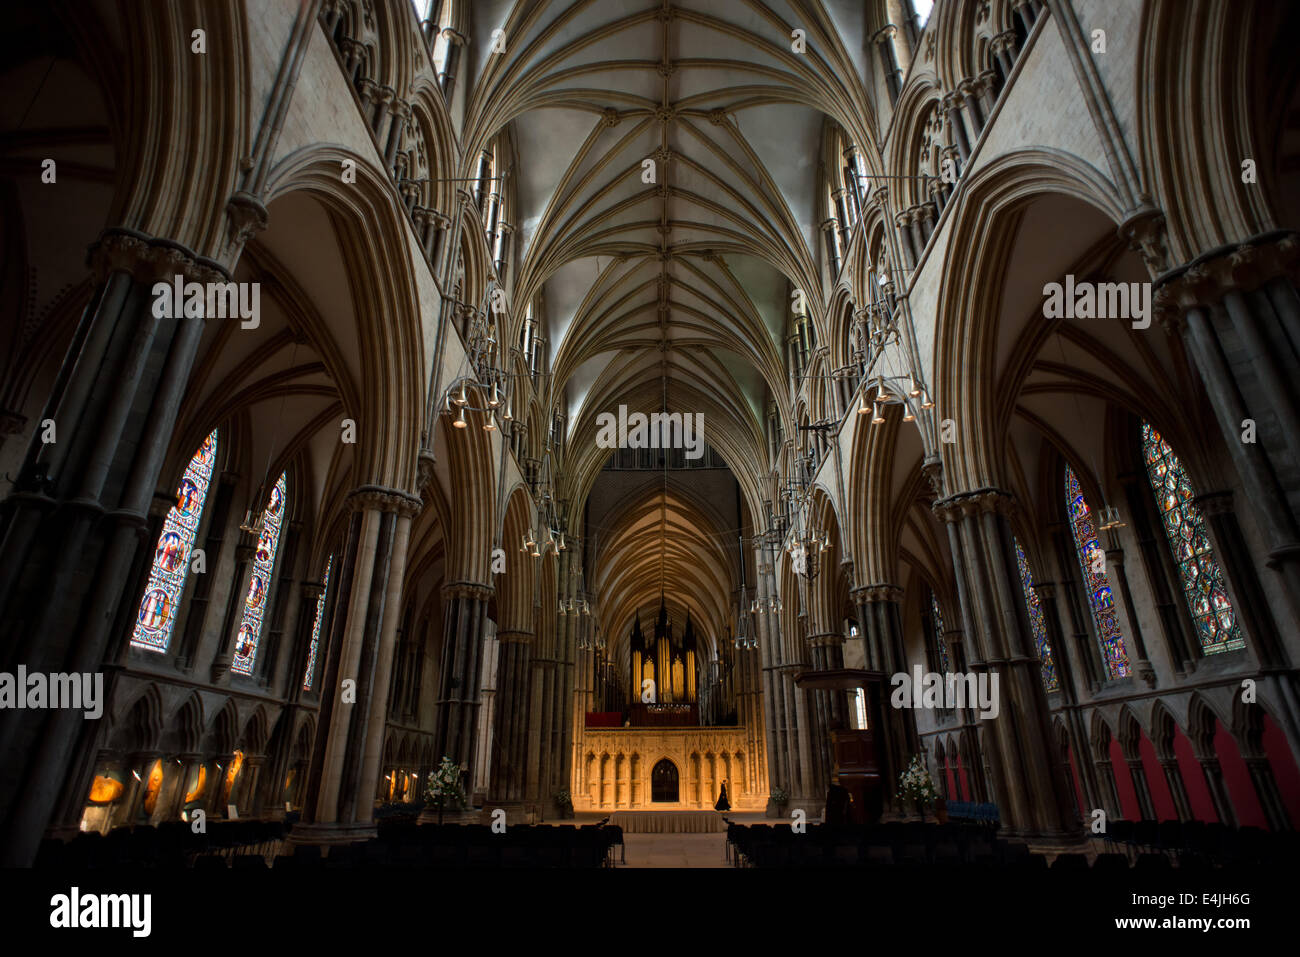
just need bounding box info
[131,429,217,651]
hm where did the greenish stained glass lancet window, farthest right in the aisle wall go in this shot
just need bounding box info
[1141,423,1245,654]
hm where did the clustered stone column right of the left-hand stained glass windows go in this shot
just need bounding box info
[294,485,421,844]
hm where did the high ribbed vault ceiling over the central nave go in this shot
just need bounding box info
[464,0,872,495]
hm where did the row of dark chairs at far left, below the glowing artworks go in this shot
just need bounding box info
[36,820,286,870]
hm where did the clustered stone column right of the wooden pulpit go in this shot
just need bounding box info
[935,489,1080,841]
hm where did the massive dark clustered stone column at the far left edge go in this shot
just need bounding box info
[0,229,227,865]
